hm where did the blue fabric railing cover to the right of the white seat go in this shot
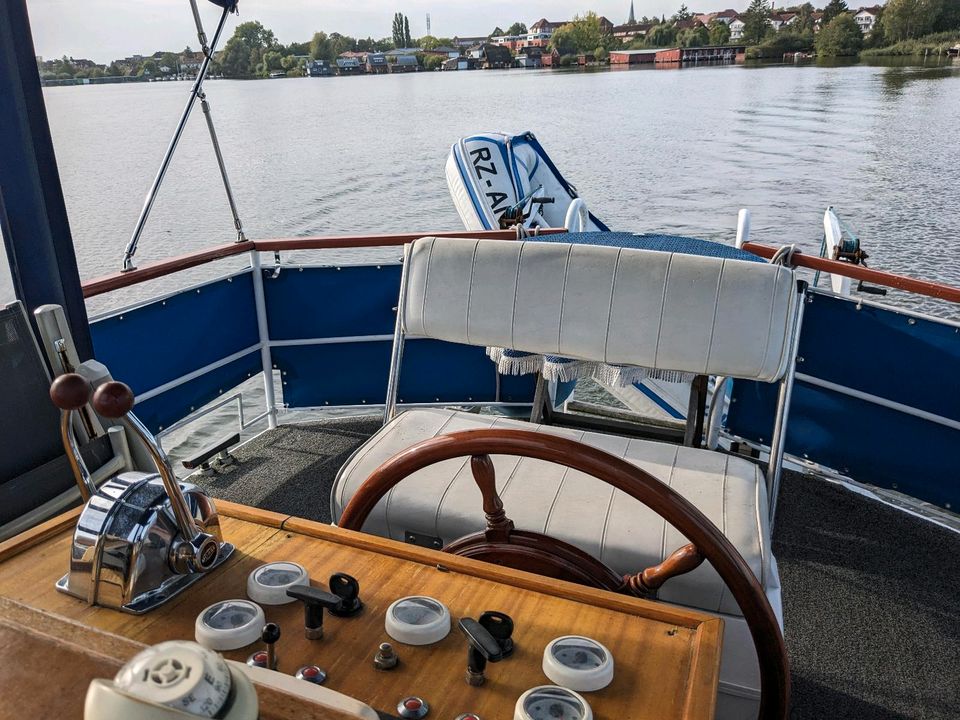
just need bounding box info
[727,295,960,507]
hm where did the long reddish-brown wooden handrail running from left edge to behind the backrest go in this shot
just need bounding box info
[83,228,566,298]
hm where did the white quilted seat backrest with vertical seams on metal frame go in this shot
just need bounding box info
[403,237,799,382]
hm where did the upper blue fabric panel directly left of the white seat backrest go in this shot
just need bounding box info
[263,266,402,340]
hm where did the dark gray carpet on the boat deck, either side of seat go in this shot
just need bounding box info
[200,418,960,720]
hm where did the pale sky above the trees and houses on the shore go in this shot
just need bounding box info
[26,0,708,63]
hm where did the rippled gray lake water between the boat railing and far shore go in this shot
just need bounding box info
[7,57,960,312]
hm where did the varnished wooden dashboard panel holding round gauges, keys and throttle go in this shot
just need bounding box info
[0,501,722,720]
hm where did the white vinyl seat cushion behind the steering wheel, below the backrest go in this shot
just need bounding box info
[331,409,779,615]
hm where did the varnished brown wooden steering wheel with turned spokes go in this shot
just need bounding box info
[339,430,790,720]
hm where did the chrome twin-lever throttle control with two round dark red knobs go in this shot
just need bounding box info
[50,373,233,613]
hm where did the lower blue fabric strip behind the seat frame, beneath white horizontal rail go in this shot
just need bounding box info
[273,340,534,407]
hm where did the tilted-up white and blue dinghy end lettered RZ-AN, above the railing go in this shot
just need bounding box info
[446,132,608,232]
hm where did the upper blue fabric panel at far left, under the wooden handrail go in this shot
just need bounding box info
[90,273,260,394]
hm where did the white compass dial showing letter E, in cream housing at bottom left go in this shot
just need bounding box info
[114,640,231,717]
